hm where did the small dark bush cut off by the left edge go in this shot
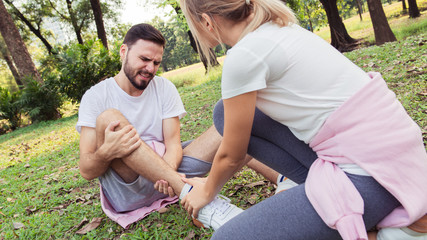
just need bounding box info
[0,87,21,132]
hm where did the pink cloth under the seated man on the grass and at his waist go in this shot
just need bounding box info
[100,141,178,229]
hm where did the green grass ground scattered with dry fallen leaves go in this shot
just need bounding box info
[0,5,427,240]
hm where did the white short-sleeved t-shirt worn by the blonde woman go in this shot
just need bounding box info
[222,23,370,143]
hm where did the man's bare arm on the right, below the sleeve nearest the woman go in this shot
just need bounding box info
[163,117,182,170]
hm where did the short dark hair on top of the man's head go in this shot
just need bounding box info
[123,23,166,48]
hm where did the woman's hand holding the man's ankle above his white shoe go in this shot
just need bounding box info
[181,178,215,218]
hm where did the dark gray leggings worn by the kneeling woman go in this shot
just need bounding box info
[212,101,400,240]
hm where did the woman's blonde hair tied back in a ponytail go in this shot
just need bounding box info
[180,0,297,65]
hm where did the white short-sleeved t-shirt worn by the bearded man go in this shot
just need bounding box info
[76,76,186,142]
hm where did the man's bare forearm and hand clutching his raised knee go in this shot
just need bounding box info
[79,121,141,180]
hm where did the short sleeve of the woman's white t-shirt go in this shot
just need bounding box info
[221,48,269,99]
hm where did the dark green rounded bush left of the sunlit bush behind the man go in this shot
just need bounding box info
[18,79,63,123]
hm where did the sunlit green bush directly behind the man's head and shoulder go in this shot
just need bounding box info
[51,40,121,102]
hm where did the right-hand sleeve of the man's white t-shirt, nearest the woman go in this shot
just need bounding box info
[161,79,187,119]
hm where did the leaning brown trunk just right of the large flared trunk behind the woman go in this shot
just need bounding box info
[368,0,397,45]
